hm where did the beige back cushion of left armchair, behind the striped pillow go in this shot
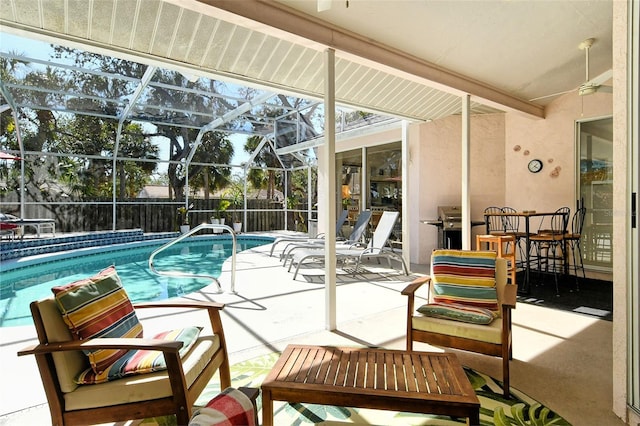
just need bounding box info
[31,297,89,393]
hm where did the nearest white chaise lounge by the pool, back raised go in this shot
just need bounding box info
[288,211,409,280]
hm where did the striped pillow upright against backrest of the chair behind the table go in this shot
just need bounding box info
[431,250,499,316]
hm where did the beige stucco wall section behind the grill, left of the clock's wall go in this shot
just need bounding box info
[409,114,505,263]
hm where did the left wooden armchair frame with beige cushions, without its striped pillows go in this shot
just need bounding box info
[18,268,231,425]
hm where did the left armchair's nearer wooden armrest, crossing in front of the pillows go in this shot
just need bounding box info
[18,338,183,356]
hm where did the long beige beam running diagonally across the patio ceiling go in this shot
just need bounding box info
[200,0,544,118]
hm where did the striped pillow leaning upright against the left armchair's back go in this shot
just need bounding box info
[51,266,142,374]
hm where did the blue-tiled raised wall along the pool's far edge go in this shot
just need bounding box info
[0,229,179,262]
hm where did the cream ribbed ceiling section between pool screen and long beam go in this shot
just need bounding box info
[0,0,504,123]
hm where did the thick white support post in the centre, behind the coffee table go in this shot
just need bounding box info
[318,49,337,330]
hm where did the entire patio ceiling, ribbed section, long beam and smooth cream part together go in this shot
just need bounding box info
[0,0,612,148]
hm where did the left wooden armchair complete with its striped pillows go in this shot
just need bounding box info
[18,267,231,425]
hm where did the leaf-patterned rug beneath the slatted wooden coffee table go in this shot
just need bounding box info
[142,353,569,426]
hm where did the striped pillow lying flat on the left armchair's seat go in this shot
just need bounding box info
[76,327,202,385]
